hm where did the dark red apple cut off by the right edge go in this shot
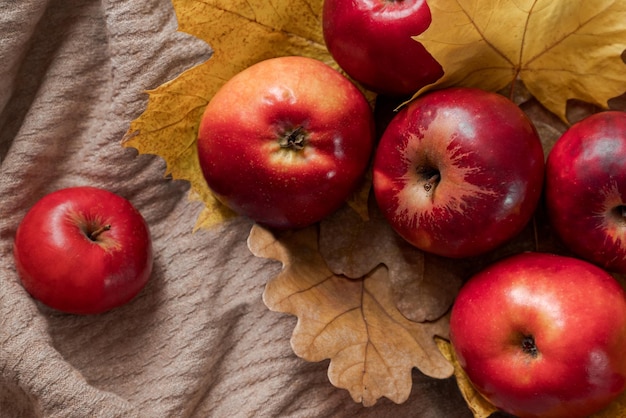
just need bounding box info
[546,111,626,273]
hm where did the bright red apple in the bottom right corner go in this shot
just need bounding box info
[450,252,626,418]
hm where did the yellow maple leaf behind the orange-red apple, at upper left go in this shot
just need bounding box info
[122,0,352,228]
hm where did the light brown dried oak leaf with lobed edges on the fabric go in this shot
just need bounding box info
[248,225,453,406]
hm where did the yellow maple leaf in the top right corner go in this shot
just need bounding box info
[415,0,626,122]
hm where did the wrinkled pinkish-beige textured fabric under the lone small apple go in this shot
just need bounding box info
[0,0,471,418]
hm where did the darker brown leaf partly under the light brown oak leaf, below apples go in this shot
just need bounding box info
[319,194,465,322]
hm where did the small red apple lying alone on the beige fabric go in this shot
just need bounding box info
[13,186,153,314]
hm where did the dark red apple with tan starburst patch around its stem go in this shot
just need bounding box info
[373,87,544,258]
